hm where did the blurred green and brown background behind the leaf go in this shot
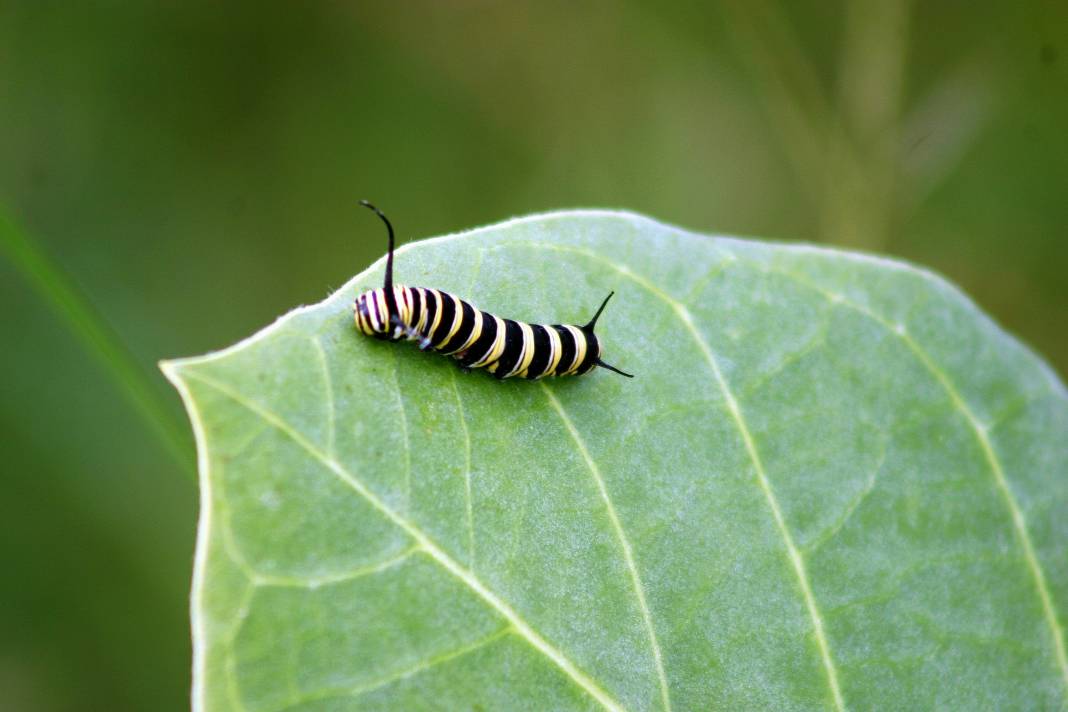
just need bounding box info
[0,0,1068,710]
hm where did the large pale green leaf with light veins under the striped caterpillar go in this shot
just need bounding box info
[164,211,1068,711]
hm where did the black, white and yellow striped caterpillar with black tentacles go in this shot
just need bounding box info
[354,201,633,380]
